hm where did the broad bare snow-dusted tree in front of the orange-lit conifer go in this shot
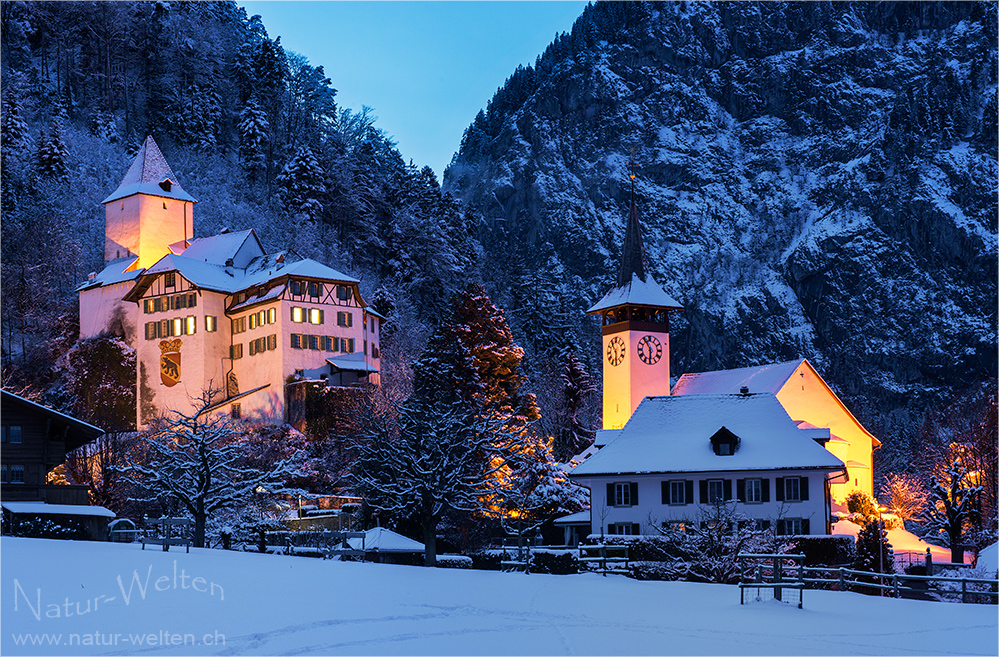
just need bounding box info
[349,396,511,566]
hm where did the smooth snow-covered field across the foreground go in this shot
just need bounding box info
[0,537,999,655]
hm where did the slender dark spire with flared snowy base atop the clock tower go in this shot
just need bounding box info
[586,176,683,314]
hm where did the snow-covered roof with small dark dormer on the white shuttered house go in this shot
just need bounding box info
[571,393,843,477]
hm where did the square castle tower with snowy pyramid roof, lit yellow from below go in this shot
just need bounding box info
[103,137,197,270]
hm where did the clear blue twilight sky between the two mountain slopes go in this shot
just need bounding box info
[238,0,587,179]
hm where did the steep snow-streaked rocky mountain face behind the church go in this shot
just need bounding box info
[445,2,997,462]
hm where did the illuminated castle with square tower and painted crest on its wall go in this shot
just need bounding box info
[78,137,383,426]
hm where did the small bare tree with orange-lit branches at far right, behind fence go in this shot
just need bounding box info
[923,446,982,563]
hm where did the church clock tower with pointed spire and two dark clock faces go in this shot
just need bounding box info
[586,174,683,429]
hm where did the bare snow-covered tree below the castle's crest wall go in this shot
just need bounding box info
[122,391,295,547]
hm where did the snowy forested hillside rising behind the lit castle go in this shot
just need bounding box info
[0,2,479,406]
